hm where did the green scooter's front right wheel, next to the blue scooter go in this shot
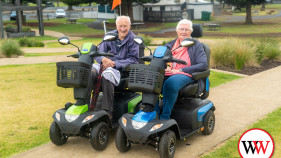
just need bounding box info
[90,122,109,151]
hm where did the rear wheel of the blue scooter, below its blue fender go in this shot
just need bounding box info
[202,110,216,135]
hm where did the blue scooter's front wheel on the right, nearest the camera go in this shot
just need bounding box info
[159,130,176,158]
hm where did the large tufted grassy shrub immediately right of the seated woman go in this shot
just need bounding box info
[211,39,256,70]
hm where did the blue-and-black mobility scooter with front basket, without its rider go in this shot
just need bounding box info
[115,24,215,158]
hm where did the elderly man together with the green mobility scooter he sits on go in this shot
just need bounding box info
[49,17,141,150]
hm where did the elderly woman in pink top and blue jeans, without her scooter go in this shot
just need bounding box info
[155,19,208,120]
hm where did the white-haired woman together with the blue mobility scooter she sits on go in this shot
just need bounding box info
[115,20,215,158]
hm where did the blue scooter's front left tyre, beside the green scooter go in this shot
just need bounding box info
[115,126,131,152]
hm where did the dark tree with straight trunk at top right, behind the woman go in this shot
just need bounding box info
[225,0,265,24]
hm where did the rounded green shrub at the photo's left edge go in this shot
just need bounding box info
[1,39,24,58]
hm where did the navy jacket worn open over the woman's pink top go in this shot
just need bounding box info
[166,39,208,75]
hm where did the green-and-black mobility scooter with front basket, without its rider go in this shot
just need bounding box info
[49,33,141,150]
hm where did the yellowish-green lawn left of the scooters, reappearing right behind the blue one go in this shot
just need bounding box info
[0,63,240,157]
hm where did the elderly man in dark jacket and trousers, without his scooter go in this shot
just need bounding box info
[91,16,139,117]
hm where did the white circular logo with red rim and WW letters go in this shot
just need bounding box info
[238,128,274,158]
